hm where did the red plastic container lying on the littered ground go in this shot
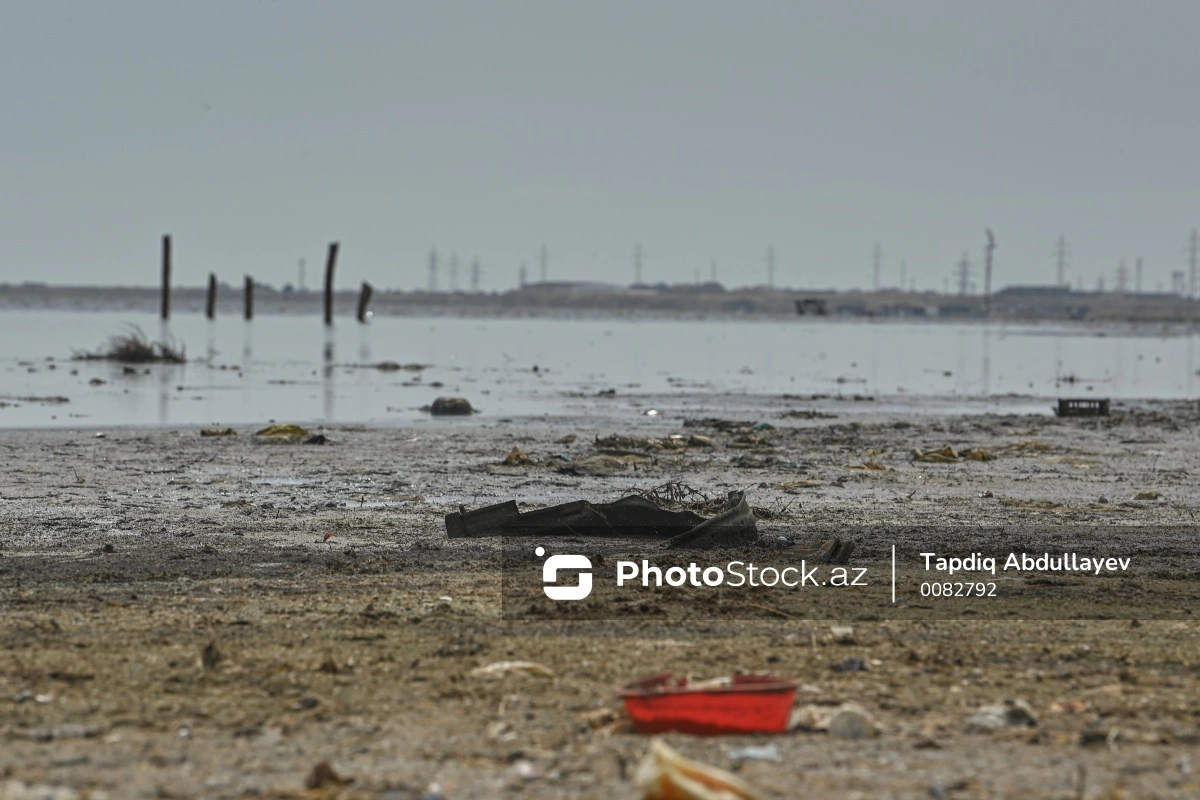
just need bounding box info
[617,673,796,736]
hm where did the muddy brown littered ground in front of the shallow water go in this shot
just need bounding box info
[0,397,1200,800]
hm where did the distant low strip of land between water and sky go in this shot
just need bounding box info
[0,282,1200,327]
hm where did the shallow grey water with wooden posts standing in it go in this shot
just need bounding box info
[0,311,1198,427]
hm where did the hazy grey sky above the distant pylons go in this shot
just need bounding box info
[0,0,1200,289]
